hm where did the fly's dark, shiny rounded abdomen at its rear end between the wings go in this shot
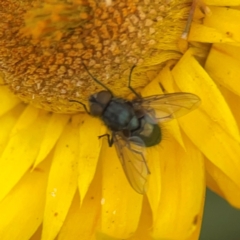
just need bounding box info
[132,114,162,147]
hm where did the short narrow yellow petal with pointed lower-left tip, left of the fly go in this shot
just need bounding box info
[33,113,69,168]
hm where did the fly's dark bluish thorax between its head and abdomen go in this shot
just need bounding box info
[102,98,139,131]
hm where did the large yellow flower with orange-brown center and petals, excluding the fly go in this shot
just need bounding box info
[0,0,240,240]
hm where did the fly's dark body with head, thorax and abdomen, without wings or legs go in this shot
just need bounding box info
[89,91,162,147]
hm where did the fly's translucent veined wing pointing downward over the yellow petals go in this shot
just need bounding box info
[113,132,150,194]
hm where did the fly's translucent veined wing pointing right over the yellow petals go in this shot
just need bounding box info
[133,92,201,122]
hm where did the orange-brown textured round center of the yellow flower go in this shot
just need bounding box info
[0,0,189,113]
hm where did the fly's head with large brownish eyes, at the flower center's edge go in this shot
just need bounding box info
[89,90,112,117]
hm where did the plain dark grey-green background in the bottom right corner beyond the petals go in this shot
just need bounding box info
[199,189,240,240]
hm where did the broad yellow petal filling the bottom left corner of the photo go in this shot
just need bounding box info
[0,159,50,240]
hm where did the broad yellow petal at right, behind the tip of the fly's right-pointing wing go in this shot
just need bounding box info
[172,51,240,206]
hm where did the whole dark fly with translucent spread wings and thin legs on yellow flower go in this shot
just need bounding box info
[69,65,200,194]
